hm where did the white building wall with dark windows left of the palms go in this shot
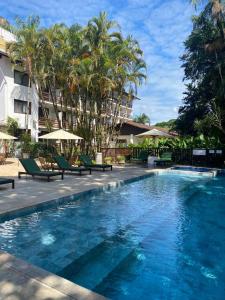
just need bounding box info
[0,28,39,140]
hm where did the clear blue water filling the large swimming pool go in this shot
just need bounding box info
[0,173,225,300]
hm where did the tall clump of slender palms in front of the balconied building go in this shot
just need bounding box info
[9,13,146,152]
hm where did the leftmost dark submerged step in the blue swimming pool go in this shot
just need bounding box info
[58,202,176,289]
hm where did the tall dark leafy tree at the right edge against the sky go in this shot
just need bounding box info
[176,2,225,139]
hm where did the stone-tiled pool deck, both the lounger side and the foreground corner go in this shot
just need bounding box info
[0,162,156,300]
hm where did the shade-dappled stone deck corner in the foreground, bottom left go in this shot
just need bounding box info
[0,251,108,300]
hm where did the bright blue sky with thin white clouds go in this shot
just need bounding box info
[0,0,196,124]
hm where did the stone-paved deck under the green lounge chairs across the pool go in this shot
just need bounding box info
[0,161,154,215]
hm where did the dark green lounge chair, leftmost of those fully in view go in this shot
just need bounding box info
[18,158,63,181]
